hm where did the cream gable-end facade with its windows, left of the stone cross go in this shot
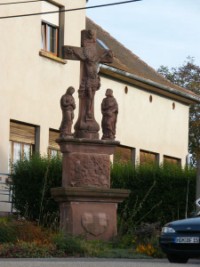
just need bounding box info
[0,0,86,214]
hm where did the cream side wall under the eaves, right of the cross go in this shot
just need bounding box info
[95,77,189,165]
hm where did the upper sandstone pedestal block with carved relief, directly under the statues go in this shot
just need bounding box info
[57,138,119,188]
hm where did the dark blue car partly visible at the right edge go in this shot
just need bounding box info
[159,217,200,263]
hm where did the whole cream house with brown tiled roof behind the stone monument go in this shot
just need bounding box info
[0,0,200,214]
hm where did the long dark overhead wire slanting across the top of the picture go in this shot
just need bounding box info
[0,0,142,19]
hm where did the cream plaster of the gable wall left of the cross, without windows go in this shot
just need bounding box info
[0,0,85,173]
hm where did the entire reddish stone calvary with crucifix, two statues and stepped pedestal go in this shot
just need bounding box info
[51,30,129,240]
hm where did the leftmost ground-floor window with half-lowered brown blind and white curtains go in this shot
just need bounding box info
[9,121,36,168]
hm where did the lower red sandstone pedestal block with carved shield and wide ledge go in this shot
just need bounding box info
[51,187,130,240]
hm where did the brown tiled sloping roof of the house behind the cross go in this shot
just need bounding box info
[86,18,200,104]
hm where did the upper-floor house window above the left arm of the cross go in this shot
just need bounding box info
[42,21,59,56]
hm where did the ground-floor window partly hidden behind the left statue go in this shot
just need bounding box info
[48,129,61,157]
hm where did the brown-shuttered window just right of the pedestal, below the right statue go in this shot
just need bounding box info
[114,146,135,163]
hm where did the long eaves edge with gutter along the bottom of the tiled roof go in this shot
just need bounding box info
[100,64,200,103]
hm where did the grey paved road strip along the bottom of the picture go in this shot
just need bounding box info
[0,258,200,267]
